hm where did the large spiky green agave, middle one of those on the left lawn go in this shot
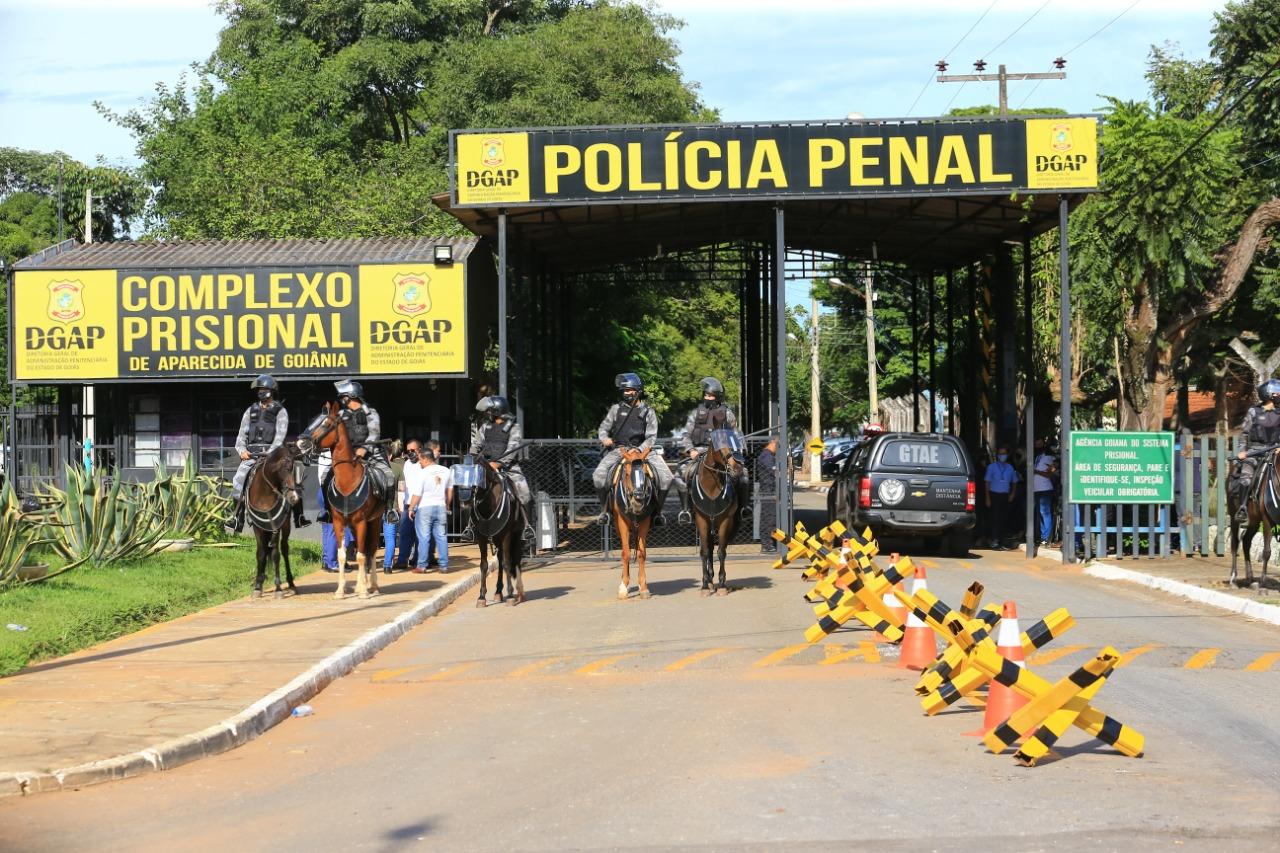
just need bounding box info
[41,465,165,566]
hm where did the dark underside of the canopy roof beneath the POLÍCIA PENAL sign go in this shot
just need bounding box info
[433,192,1084,269]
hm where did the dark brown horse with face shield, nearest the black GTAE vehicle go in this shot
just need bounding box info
[689,429,746,596]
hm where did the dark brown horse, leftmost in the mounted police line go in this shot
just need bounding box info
[244,444,302,598]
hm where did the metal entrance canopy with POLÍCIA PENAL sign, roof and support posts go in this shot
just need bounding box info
[433,117,1098,558]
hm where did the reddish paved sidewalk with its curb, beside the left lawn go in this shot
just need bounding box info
[0,548,479,797]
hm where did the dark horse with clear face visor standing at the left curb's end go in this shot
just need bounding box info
[453,455,526,607]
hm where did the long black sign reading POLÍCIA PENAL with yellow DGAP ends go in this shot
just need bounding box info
[449,117,1098,206]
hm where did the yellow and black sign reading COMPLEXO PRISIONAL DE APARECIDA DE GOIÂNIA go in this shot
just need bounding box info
[9,261,467,382]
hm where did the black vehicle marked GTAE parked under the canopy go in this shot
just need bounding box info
[827,433,977,556]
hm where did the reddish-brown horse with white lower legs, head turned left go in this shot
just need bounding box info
[298,403,385,601]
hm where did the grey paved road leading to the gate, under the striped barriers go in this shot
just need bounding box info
[0,498,1280,852]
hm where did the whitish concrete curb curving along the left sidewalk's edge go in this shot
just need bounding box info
[0,569,480,798]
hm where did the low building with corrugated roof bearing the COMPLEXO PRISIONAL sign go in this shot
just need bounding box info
[6,237,495,489]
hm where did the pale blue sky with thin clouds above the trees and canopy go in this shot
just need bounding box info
[0,0,1222,164]
